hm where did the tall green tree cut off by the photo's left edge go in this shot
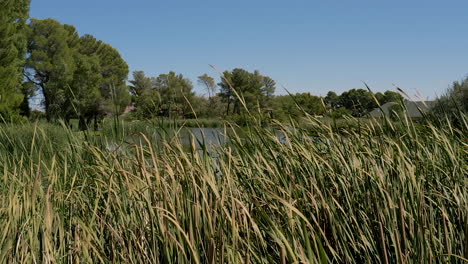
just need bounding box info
[0,0,30,121]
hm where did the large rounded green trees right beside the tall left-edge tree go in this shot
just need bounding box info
[27,19,130,126]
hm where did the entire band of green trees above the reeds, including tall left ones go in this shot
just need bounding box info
[0,0,460,129]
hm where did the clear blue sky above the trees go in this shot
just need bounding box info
[31,0,468,98]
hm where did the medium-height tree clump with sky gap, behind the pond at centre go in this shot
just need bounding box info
[130,68,276,119]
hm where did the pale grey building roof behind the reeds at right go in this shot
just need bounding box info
[369,100,435,119]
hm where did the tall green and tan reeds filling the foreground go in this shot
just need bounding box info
[0,114,468,263]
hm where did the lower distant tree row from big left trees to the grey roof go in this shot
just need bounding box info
[130,68,403,120]
